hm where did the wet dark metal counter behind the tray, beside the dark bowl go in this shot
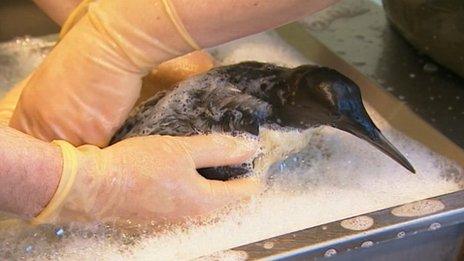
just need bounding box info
[306,0,464,147]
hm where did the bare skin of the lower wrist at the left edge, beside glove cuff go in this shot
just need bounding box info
[0,126,62,218]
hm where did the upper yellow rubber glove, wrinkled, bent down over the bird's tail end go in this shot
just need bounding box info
[10,0,201,147]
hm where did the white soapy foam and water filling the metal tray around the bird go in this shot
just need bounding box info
[0,34,463,260]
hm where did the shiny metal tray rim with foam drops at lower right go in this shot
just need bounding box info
[234,191,464,260]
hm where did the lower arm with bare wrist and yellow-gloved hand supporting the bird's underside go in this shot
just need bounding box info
[0,126,260,223]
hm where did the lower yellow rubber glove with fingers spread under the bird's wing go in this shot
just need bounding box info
[33,134,261,223]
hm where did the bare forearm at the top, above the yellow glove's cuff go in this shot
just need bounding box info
[176,0,339,47]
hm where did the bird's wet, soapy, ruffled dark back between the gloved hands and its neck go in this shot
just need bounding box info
[112,66,278,143]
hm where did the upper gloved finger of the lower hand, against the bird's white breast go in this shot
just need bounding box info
[176,134,258,169]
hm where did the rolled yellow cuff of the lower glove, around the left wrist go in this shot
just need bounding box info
[31,140,78,225]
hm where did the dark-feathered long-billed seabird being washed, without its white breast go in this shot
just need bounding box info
[111,62,415,180]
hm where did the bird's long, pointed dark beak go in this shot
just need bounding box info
[334,115,416,173]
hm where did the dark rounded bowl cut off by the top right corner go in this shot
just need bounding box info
[383,0,464,77]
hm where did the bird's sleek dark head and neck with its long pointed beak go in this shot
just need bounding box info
[274,65,415,173]
